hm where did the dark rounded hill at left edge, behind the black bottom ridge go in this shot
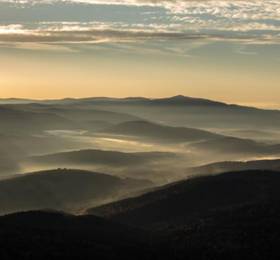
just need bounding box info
[0,169,151,214]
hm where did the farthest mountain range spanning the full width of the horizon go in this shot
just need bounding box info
[2,95,280,131]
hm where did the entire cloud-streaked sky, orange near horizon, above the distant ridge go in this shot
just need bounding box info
[0,0,280,108]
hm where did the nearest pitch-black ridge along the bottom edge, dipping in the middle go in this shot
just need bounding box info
[0,205,280,260]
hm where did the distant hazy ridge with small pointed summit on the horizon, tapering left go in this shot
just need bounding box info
[54,95,280,130]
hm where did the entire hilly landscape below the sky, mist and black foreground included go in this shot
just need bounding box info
[0,96,280,260]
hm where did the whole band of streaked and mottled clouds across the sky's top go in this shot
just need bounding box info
[0,0,280,52]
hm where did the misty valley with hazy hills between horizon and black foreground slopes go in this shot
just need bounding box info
[0,97,280,213]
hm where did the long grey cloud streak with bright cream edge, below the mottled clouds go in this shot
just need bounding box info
[0,23,280,43]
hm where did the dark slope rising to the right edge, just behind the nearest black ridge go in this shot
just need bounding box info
[89,171,280,228]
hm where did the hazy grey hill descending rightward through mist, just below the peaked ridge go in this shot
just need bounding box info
[101,121,280,161]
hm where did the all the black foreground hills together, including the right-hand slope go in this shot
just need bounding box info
[0,172,280,260]
